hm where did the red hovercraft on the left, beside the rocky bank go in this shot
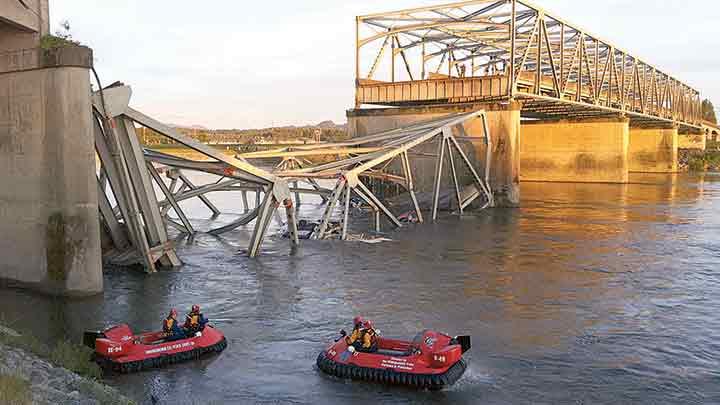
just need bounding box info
[83,325,227,373]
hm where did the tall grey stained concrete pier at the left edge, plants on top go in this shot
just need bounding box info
[0,48,103,295]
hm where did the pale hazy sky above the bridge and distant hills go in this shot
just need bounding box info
[50,0,720,128]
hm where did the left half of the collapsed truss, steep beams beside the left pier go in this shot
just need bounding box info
[93,86,298,264]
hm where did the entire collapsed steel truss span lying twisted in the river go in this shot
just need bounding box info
[93,85,494,272]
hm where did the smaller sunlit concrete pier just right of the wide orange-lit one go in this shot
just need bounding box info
[628,126,678,173]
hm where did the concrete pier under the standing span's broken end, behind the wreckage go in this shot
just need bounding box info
[347,102,521,207]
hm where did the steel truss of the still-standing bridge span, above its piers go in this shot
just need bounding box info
[356,0,701,129]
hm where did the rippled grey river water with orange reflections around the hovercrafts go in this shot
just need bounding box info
[0,174,720,404]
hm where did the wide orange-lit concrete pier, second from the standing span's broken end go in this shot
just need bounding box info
[520,118,630,183]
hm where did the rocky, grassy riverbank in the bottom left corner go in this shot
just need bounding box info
[0,325,134,405]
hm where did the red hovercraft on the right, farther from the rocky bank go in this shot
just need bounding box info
[317,318,470,390]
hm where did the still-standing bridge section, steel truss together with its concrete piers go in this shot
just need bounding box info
[348,0,701,205]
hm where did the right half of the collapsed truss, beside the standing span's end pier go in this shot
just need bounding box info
[238,111,494,240]
